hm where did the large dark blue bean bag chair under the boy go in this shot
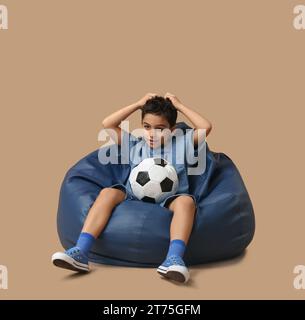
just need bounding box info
[57,122,255,267]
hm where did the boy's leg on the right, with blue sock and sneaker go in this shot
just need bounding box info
[157,195,196,282]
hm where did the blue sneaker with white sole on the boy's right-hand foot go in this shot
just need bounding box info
[157,255,190,283]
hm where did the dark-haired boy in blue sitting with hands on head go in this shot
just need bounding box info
[52,93,212,283]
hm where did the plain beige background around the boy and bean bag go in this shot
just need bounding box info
[0,0,305,299]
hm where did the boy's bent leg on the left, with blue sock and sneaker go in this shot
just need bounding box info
[52,187,125,271]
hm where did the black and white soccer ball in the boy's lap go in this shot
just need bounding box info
[129,158,179,203]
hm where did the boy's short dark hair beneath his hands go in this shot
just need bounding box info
[142,96,177,127]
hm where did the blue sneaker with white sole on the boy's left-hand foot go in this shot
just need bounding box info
[52,247,89,272]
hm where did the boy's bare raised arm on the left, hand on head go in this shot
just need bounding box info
[102,93,155,144]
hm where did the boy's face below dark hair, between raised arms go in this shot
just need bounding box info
[142,113,175,148]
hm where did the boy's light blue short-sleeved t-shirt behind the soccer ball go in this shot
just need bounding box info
[121,129,206,205]
